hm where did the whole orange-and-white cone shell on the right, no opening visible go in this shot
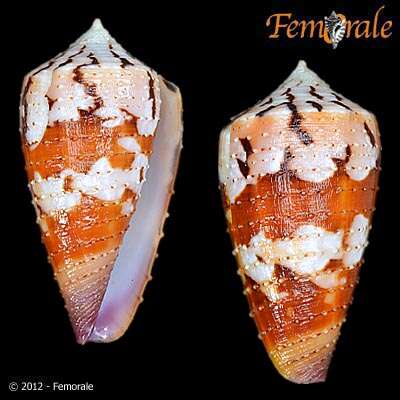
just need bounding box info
[219,61,381,383]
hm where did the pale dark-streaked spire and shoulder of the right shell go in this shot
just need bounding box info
[220,62,380,203]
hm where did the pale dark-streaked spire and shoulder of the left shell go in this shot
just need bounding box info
[21,20,161,149]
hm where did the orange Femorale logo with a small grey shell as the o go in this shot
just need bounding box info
[266,6,393,49]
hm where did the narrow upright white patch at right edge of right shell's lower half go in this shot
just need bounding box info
[343,214,369,267]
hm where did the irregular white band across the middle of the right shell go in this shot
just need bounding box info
[235,214,369,301]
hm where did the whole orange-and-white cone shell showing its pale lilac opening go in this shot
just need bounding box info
[20,20,182,343]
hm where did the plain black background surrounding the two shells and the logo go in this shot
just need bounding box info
[1,1,400,398]
